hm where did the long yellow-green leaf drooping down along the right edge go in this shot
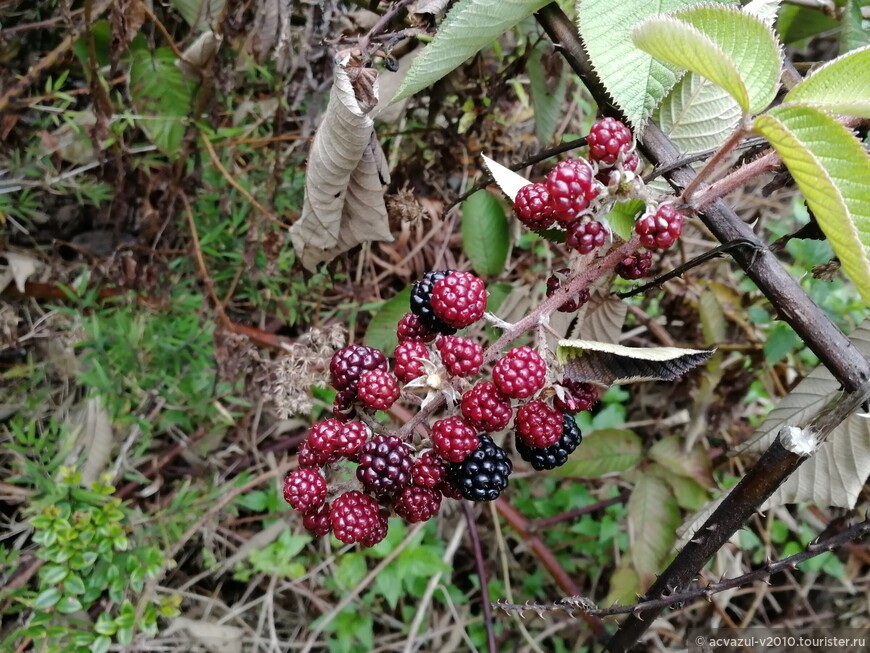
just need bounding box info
[755,106,870,305]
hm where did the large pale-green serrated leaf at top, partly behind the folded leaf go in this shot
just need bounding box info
[577,0,732,128]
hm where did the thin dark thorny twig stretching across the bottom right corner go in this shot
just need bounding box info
[493,513,870,617]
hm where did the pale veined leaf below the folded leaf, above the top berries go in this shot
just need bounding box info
[656,71,742,154]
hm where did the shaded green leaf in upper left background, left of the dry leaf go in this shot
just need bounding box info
[129,48,194,157]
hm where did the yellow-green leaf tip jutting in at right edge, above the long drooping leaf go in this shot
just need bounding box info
[783,46,870,118]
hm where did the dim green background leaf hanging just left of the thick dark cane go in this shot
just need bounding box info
[526,45,568,145]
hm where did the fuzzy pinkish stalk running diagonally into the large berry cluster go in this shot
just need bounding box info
[397,236,640,440]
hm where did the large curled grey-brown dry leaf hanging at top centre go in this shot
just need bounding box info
[290,51,393,270]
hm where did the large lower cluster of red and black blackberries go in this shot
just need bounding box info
[283,270,597,546]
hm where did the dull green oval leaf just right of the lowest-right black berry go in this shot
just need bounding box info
[553,429,643,477]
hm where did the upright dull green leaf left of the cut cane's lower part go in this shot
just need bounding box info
[626,474,680,587]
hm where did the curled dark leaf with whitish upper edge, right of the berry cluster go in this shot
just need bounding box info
[556,340,715,386]
